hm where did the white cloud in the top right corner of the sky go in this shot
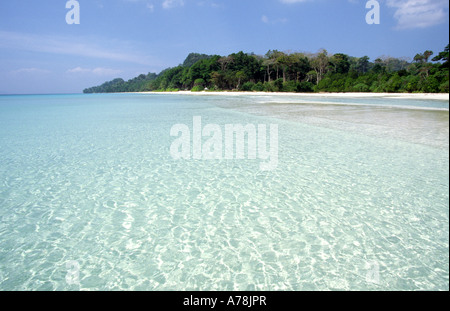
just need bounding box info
[386,0,449,29]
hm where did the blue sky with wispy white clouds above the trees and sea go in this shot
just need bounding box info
[0,0,449,94]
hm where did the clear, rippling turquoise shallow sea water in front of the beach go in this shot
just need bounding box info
[0,94,449,290]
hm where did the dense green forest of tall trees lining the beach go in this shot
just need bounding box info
[84,45,449,93]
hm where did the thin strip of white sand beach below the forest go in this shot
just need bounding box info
[135,91,449,100]
